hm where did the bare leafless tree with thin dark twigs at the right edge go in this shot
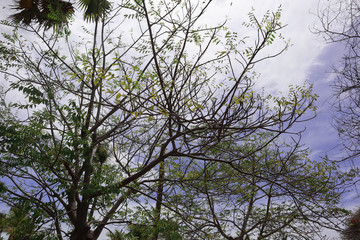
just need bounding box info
[315,0,360,161]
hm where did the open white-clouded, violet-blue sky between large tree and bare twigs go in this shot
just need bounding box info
[0,0,360,239]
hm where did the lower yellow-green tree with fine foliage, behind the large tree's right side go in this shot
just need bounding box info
[164,133,347,240]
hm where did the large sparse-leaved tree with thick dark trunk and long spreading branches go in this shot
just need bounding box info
[0,0,348,240]
